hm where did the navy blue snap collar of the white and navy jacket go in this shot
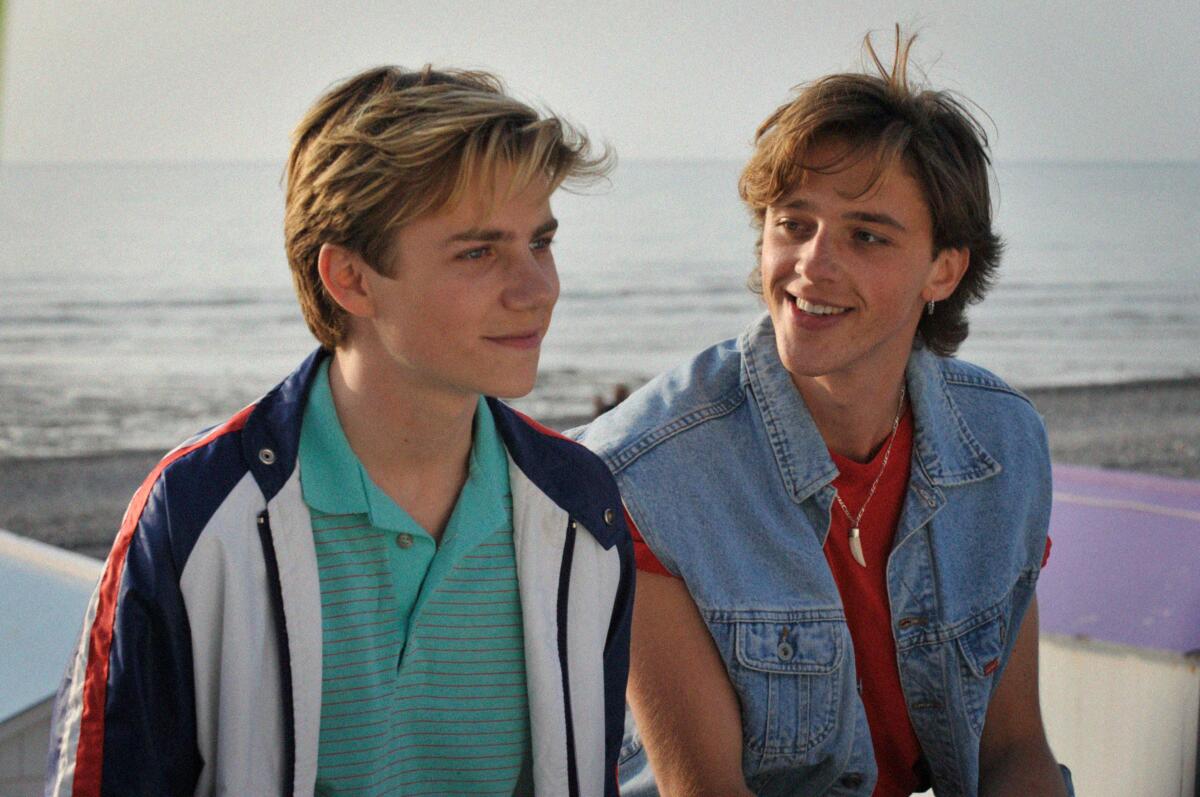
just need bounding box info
[241,349,628,549]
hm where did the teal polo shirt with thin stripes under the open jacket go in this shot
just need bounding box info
[300,361,530,796]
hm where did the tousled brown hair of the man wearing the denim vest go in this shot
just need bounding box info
[738,26,1003,356]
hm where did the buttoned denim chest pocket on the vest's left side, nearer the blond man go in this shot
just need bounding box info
[730,621,846,759]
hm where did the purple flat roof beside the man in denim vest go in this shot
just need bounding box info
[1038,463,1200,654]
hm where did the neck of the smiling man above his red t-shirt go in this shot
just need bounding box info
[792,362,905,462]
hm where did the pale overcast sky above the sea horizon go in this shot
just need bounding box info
[0,0,1200,162]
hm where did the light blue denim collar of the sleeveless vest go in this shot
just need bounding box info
[738,313,1001,502]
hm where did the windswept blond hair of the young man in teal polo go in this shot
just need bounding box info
[284,66,612,349]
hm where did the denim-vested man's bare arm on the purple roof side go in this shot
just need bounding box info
[979,598,1067,797]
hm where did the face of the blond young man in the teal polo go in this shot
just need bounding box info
[355,173,558,397]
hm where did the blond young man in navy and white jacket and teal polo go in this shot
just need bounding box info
[47,67,634,796]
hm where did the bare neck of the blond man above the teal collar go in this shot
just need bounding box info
[329,346,479,484]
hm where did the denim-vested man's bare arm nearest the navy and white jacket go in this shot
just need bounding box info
[629,571,750,797]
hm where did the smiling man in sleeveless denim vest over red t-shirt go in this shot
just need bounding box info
[580,29,1070,797]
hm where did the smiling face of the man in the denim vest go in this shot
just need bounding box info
[761,144,966,385]
